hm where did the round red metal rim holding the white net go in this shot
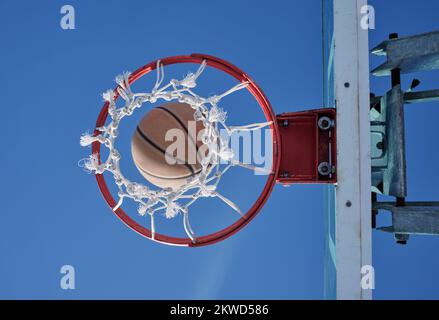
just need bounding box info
[92,54,281,247]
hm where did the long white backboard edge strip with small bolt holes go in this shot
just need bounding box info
[334,0,372,299]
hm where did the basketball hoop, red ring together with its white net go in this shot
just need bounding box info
[81,54,281,247]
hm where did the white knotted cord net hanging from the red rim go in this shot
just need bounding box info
[80,61,271,241]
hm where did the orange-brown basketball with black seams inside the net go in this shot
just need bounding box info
[131,102,204,189]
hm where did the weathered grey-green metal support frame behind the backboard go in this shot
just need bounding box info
[370,31,439,244]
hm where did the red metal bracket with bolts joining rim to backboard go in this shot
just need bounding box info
[276,108,337,185]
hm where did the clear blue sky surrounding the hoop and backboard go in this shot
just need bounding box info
[0,0,439,299]
